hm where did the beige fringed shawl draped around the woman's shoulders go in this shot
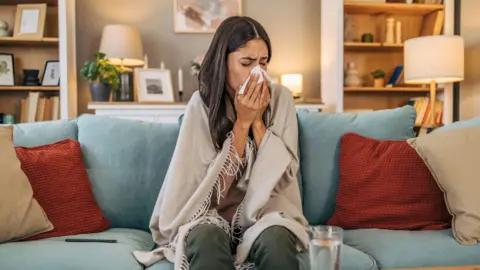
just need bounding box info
[134,85,308,270]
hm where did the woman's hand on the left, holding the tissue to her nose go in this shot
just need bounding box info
[235,75,268,128]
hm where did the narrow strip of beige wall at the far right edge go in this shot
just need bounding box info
[460,0,480,120]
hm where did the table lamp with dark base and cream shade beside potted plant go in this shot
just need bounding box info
[99,24,145,101]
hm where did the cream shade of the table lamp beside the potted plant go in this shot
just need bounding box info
[99,24,144,66]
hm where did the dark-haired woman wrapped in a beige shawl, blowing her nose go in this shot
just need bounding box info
[135,17,308,270]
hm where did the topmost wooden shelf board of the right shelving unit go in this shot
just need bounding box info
[344,3,445,15]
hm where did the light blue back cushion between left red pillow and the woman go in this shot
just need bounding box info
[78,115,178,230]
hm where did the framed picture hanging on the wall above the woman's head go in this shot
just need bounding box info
[173,0,242,33]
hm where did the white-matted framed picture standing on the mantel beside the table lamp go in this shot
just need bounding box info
[135,68,175,102]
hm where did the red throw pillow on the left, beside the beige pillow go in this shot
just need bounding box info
[15,139,110,240]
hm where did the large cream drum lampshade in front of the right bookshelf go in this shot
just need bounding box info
[404,35,465,84]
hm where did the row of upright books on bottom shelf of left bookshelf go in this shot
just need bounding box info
[20,92,60,123]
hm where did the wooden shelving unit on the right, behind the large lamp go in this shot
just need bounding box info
[343,2,445,113]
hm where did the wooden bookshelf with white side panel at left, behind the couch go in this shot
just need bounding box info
[0,0,77,123]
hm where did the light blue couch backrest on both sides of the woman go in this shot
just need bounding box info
[10,106,416,231]
